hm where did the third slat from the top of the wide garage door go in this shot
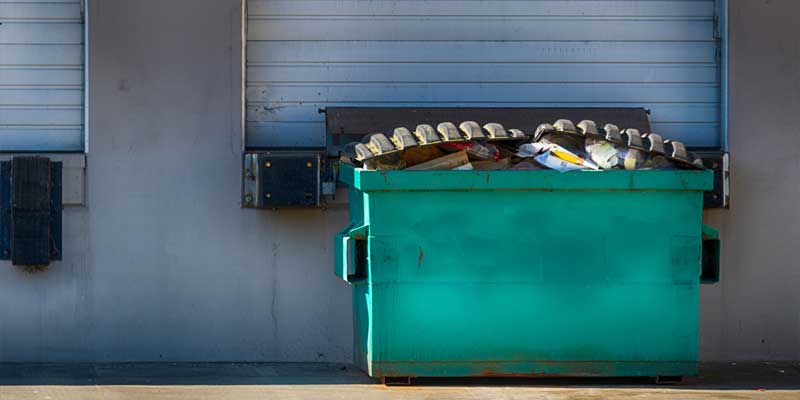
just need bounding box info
[247,41,716,65]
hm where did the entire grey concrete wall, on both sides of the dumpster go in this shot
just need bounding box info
[0,0,800,362]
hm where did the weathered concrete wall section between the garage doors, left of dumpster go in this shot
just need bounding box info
[0,0,352,361]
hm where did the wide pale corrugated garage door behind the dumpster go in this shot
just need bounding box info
[247,0,721,148]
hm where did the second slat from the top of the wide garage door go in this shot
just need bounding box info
[248,17,714,41]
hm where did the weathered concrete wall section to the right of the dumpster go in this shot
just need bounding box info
[701,0,800,360]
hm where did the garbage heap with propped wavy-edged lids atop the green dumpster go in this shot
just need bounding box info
[342,119,704,172]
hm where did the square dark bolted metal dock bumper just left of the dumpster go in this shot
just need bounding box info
[242,152,325,209]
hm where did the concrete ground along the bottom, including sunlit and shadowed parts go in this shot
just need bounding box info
[0,363,800,400]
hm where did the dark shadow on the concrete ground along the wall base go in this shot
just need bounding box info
[0,363,800,390]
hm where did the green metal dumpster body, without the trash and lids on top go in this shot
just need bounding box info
[335,165,719,379]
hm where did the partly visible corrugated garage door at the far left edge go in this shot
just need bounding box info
[0,0,84,151]
